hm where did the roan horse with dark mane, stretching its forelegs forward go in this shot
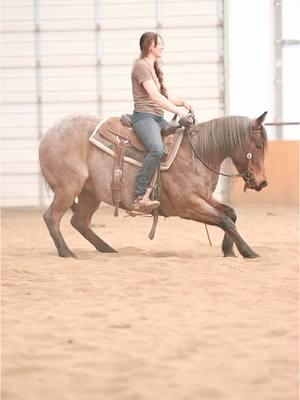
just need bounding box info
[39,112,267,258]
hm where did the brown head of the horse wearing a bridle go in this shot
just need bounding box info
[232,111,268,191]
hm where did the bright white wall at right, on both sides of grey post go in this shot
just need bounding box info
[228,0,300,140]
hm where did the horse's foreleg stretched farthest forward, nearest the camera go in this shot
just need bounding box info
[187,200,259,258]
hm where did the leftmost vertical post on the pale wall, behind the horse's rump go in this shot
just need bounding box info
[34,0,44,206]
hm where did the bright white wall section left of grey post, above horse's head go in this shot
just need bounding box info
[228,0,274,125]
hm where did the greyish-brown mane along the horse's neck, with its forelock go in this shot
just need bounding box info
[191,116,267,159]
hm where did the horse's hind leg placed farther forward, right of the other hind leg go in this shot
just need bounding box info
[71,190,116,253]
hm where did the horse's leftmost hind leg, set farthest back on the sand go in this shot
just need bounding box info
[44,189,76,258]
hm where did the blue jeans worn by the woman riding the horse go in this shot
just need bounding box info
[132,112,167,197]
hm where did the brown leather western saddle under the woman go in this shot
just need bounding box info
[99,114,179,216]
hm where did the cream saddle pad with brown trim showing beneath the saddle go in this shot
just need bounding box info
[89,120,183,171]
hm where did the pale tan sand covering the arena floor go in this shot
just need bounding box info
[2,206,299,400]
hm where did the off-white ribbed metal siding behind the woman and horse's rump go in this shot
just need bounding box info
[1,0,224,206]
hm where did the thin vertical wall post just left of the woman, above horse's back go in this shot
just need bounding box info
[95,0,103,118]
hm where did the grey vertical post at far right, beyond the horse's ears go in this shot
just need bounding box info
[274,0,283,140]
